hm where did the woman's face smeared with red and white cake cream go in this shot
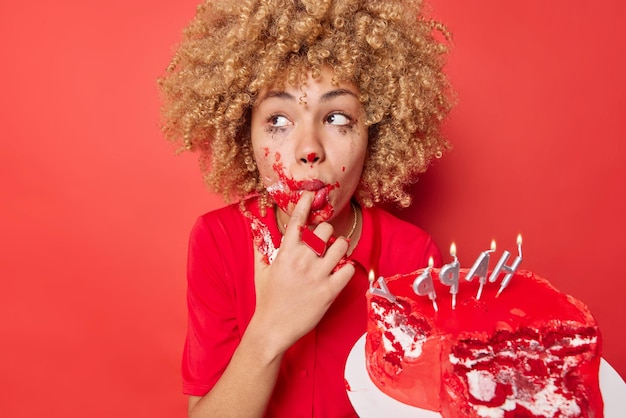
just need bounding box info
[251,68,368,224]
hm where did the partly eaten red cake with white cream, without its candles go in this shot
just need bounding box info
[365,269,603,418]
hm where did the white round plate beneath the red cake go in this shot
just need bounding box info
[345,334,626,418]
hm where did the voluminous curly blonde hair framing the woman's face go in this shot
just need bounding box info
[159,0,452,207]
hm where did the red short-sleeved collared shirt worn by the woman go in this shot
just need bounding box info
[182,199,441,418]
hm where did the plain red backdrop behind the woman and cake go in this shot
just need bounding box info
[0,0,626,418]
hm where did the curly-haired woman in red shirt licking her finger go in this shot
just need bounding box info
[160,0,450,417]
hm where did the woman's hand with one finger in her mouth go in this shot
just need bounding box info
[250,192,355,355]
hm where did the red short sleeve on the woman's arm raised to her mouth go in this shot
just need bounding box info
[182,214,249,396]
